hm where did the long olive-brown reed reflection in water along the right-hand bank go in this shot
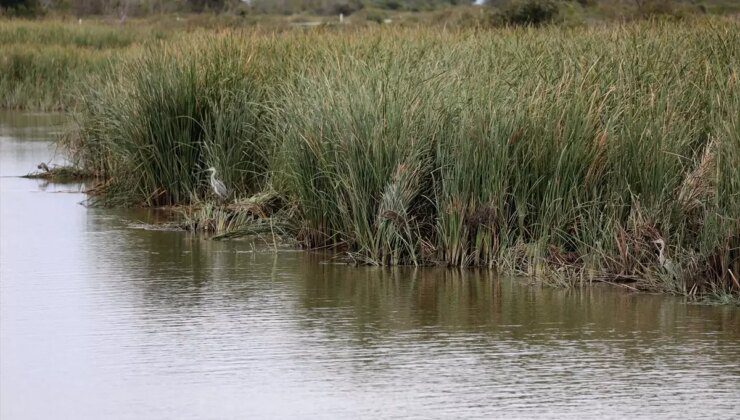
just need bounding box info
[294,253,740,338]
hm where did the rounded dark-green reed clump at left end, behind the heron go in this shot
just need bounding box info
[69,37,269,205]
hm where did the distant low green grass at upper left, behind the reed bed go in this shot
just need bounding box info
[0,20,173,111]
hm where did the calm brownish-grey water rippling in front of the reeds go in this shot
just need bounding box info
[0,113,740,420]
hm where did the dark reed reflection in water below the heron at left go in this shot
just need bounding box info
[90,215,291,308]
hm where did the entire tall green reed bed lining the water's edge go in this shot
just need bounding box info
[70,20,740,295]
